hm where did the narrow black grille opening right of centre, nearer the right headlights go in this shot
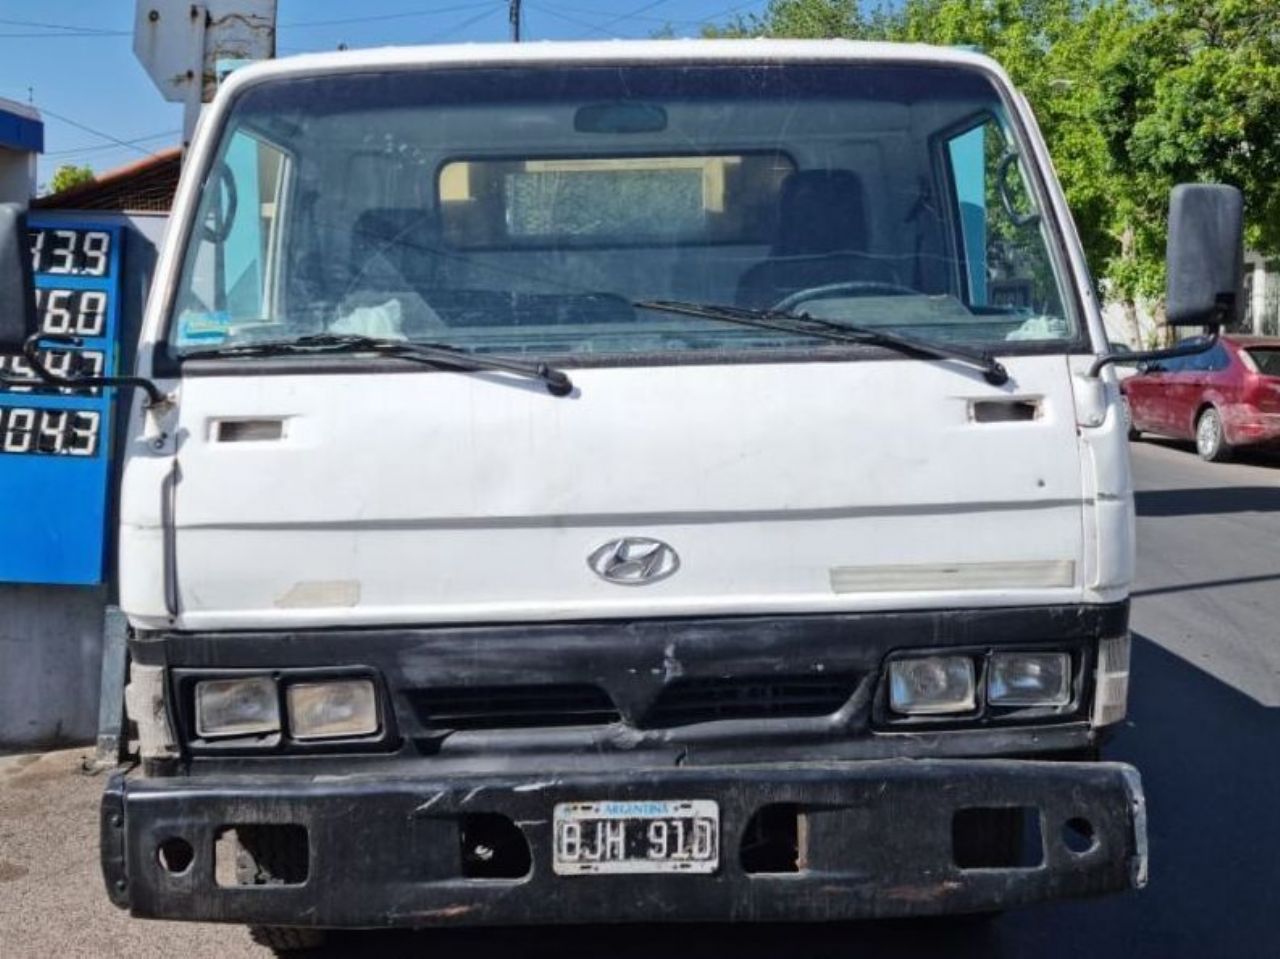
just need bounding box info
[641,673,858,727]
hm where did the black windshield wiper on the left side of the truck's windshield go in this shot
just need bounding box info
[183,333,573,396]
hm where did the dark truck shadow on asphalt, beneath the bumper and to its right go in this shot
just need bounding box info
[304,638,1280,959]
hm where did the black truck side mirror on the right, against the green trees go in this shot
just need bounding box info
[1165,183,1244,326]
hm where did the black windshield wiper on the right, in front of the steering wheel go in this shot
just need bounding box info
[631,300,1009,387]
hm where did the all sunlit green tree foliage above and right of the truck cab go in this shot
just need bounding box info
[708,0,1280,313]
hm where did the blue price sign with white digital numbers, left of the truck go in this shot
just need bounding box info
[0,215,122,585]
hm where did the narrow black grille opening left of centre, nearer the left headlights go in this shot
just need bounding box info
[410,684,621,730]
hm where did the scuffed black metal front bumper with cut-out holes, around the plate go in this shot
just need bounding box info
[101,759,1146,927]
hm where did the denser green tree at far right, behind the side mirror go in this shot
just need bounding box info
[1097,0,1280,317]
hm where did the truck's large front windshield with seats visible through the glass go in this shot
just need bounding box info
[169,64,1078,360]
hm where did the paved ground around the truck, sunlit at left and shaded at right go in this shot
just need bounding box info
[0,443,1280,959]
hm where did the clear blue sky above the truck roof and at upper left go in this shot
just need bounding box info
[0,0,767,184]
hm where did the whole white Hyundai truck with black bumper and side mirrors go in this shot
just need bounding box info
[0,41,1240,949]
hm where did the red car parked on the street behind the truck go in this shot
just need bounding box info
[1120,335,1280,462]
